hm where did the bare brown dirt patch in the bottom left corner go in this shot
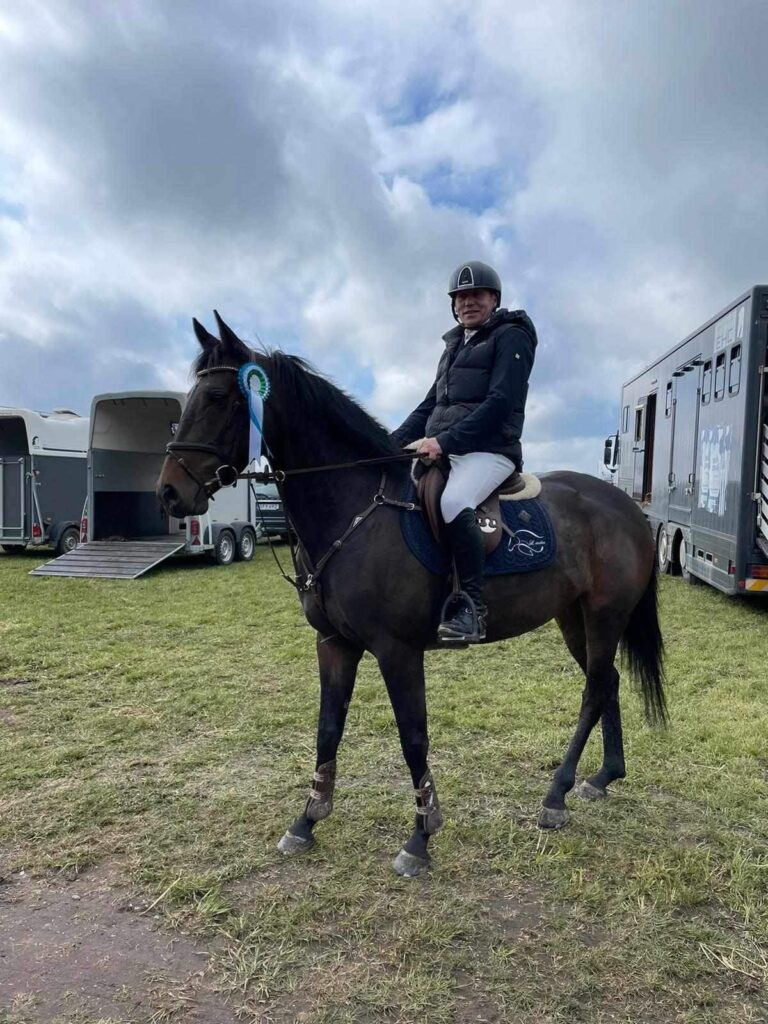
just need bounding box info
[0,866,238,1024]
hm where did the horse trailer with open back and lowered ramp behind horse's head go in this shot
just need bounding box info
[32,391,259,580]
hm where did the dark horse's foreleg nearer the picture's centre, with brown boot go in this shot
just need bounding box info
[378,645,442,878]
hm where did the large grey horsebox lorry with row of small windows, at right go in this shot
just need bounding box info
[603,285,768,594]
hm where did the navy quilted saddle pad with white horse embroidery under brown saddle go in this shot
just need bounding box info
[400,480,557,577]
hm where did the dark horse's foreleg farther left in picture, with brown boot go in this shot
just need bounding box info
[278,634,362,853]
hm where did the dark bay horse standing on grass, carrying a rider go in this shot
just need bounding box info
[157,313,667,877]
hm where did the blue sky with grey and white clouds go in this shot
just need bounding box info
[0,0,768,472]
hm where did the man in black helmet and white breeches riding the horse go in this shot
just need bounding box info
[392,260,537,643]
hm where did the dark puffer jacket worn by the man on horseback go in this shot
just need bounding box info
[392,309,538,469]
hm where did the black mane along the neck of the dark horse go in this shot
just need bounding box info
[193,329,398,457]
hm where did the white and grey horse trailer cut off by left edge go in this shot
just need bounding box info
[0,408,88,554]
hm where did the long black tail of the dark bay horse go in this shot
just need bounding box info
[622,561,669,725]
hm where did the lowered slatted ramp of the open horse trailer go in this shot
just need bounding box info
[30,537,184,580]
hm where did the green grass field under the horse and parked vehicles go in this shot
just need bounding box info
[0,548,768,1024]
